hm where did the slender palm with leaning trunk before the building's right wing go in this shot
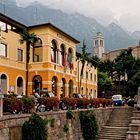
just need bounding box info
[78,41,90,93]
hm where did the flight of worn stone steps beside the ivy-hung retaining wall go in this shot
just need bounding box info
[99,107,133,140]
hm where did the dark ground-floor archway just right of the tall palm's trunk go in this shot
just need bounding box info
[33,75,42,95]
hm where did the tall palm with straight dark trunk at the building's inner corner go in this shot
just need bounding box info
[20,29,37,96]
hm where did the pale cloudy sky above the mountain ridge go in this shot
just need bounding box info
[17,0,140,31]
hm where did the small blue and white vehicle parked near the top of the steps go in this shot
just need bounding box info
[112,94,124,106]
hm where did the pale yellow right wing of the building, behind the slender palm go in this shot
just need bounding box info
[75,53,97,98]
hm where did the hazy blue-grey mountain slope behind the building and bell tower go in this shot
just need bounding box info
[0,0,138,52]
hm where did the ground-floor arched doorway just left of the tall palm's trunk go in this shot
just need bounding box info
[17,77,23,95]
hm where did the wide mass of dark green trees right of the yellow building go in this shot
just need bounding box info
[98,48,140,96]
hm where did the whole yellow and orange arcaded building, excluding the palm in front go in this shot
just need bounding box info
[0,14,97,97]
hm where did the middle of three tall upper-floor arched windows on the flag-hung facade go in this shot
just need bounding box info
[60,44,66,66]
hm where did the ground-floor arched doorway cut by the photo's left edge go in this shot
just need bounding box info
[0,74,7,94]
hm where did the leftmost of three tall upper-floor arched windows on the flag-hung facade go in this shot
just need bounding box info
[51,40,57,63]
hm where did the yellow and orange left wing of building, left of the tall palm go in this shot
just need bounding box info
[0,14,26,94]
